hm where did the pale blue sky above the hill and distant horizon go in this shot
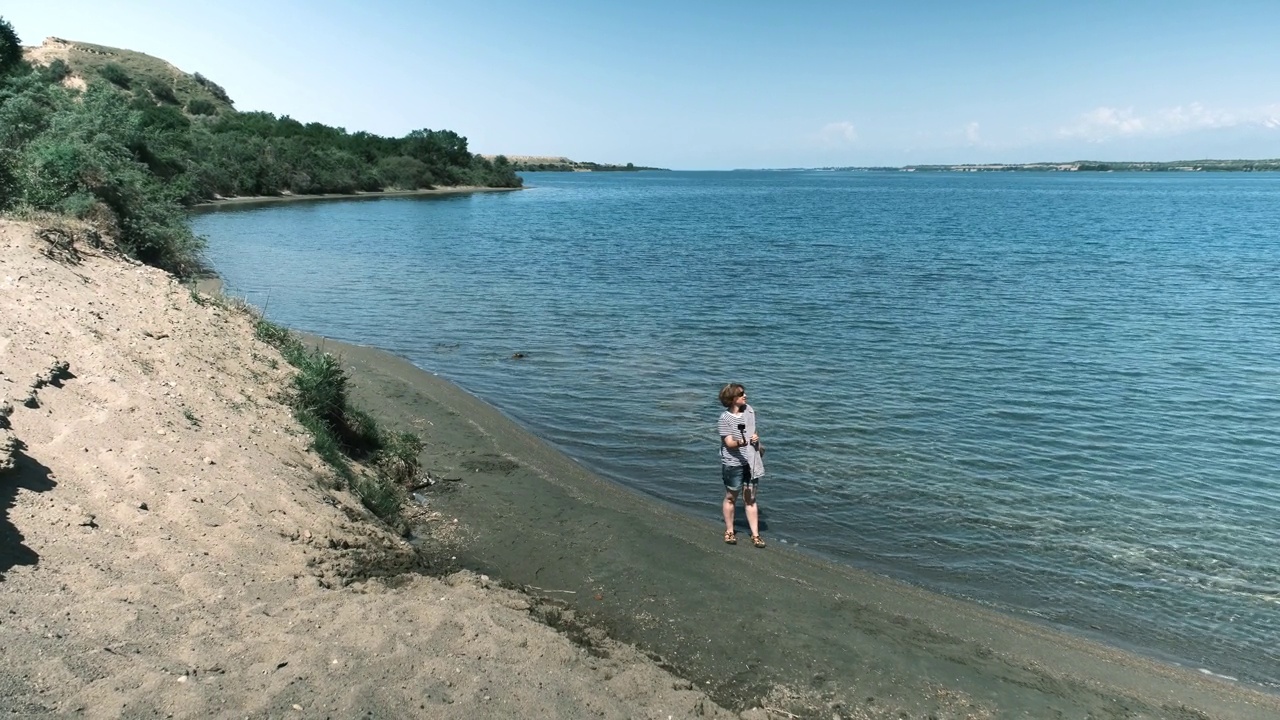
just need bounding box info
[0,0,1280,169]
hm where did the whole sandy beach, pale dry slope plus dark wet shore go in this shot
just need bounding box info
[0,220,1280,719]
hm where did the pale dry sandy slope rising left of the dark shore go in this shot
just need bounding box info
[0,220,727,719]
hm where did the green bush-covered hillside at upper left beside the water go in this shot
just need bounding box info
[0,18,521,275]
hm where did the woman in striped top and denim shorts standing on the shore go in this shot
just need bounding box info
[718,383,764,547]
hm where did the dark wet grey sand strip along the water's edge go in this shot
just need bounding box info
[319,340,1280,719]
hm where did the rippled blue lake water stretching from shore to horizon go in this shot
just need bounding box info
[195,172,1280,688]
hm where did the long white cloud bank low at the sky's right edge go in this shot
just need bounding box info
[1057,102,1280,142]
